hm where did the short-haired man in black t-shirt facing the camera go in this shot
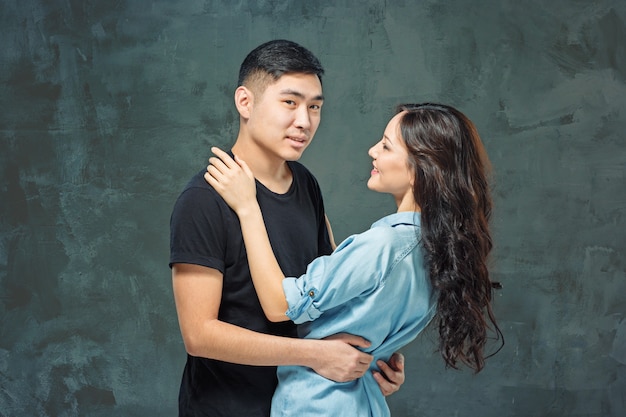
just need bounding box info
[170,40,404,417]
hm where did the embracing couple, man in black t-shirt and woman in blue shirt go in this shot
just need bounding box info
[170,41,497,416]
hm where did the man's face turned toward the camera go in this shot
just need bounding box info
[247,74,324,161]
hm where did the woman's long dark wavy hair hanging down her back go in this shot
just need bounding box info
[396,103,504,372]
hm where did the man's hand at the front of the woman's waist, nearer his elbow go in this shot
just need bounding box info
[311,333,374,382]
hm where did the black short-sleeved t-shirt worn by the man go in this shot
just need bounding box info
[170,158,331,417]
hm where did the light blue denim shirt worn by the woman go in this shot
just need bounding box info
[272,212,436,417]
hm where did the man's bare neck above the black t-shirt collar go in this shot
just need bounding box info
[232,139,293,194]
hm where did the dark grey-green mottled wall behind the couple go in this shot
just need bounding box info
[0,0,626,417]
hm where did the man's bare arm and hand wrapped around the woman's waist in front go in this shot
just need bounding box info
[172,264,372,382]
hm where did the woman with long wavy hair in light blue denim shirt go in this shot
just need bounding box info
[205,103,501,416]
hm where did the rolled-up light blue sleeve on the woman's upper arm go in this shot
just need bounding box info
[283,230,393,324]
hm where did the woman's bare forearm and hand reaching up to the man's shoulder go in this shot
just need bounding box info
[204,147,289,322]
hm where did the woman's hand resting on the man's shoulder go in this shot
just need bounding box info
[204,146,258,214]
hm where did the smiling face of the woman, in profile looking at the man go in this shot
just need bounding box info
[367,112,415,211]
